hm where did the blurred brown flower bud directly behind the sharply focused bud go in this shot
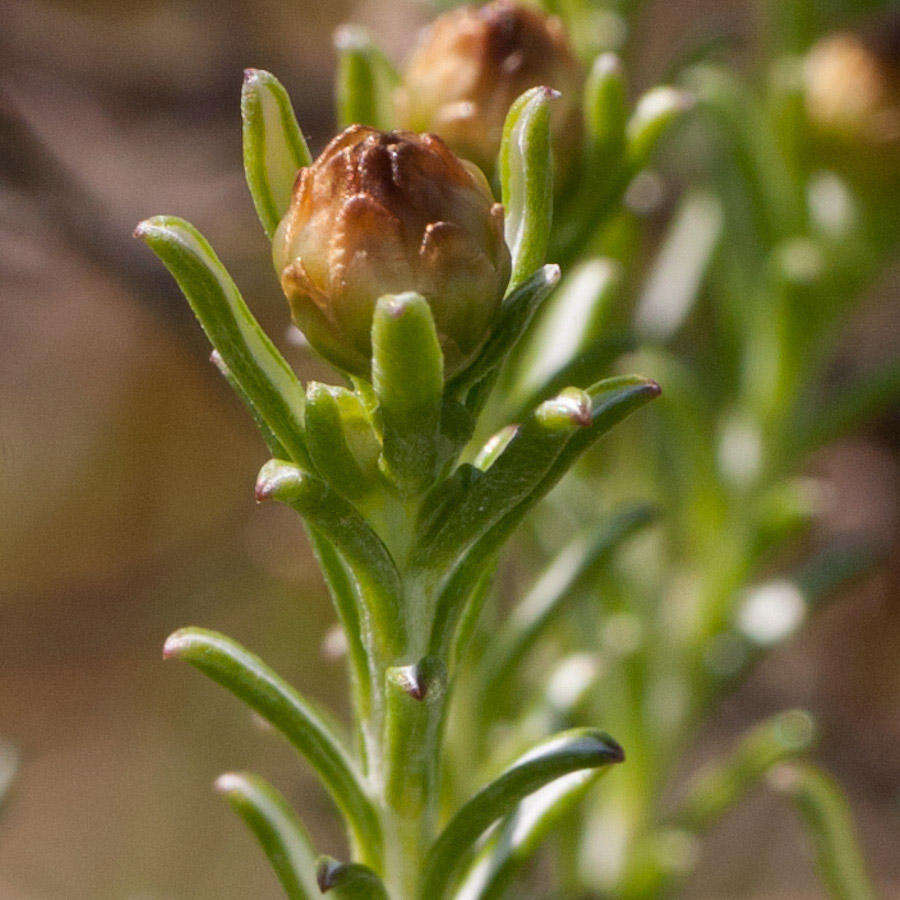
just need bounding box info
[397,0,582,173]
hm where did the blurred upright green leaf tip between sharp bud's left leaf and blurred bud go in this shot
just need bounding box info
[334,25,399,131]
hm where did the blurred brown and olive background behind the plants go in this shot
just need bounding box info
[0,0,900,898]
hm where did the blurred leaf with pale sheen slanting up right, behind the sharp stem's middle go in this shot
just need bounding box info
[482,503,656,708]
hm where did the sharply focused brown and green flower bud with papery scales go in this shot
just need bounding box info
[273,125,510,378]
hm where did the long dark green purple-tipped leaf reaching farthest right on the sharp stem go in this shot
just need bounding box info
[429,375,660,654]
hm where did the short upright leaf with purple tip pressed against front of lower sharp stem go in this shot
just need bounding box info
[383,657,447,819]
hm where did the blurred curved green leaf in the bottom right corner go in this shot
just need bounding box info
[769,763,876,900]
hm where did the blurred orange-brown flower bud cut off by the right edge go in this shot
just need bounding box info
[804,19,900,144]
